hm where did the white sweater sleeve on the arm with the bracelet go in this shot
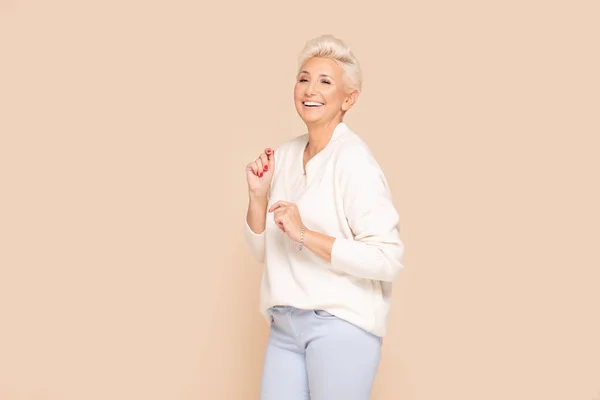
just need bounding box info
[331,148,404,282]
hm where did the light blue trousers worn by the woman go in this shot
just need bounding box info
[260,306,382,400]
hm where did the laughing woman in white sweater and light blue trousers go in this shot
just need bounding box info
[245,35,404,400]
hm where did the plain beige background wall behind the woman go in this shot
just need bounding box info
[0,0,600,400]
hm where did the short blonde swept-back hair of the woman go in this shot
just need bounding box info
[298,35,362,92]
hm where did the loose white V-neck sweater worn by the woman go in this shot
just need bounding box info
[245,122,404,336]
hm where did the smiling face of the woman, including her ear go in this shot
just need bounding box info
[294,57,358,125]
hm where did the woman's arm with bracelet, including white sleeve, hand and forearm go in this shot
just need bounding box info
[268,147,404,282]
